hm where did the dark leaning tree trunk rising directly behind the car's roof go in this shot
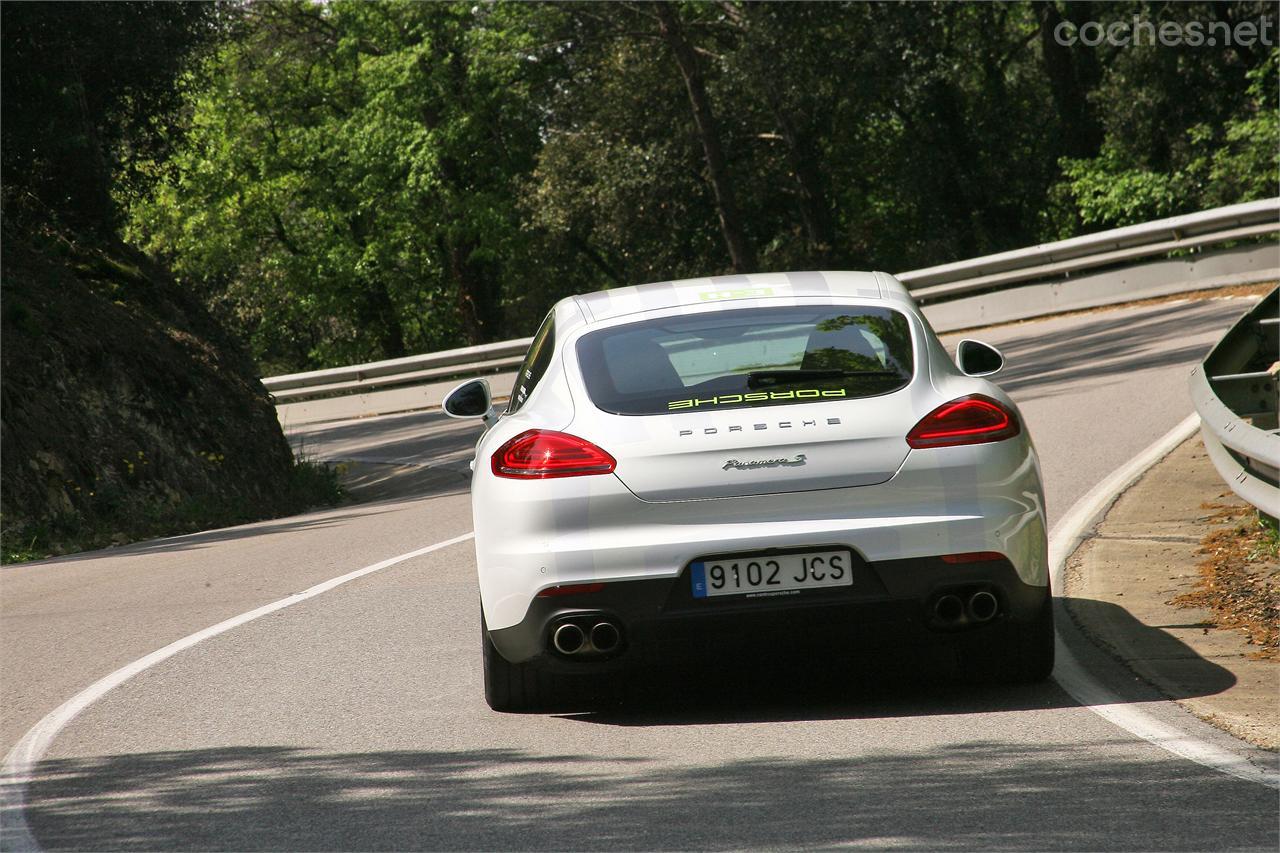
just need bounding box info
[654,3,755,273]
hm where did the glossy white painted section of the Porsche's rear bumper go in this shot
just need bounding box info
[472,437,1048,630]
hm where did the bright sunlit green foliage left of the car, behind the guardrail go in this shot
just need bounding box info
[129,3,560,369]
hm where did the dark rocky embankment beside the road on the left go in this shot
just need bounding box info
[0,223,332,561]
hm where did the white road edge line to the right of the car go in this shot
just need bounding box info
[1048,415,1280,788]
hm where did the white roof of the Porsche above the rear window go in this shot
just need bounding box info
[568,270,911,333]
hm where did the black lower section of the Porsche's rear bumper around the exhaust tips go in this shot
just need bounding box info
[490,557,1050,671]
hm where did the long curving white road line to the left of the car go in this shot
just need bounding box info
[0,533,475,852]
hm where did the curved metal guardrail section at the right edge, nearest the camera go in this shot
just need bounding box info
[1189,288,1280,519]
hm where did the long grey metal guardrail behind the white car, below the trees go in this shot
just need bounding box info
[262,197,1280,402]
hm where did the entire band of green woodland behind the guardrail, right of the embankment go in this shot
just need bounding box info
[122,0,1280,373]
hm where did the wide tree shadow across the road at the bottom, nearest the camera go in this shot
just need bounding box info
[27,729,1277,850]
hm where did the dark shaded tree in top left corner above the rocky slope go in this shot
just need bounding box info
[0,3,218,234]
